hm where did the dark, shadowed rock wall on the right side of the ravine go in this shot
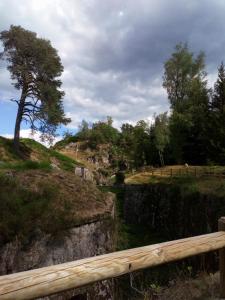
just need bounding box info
[124,183,225,240]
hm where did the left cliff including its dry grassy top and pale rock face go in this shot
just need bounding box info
[0,171,115,300]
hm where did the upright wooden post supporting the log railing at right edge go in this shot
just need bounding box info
[218,217,225,299]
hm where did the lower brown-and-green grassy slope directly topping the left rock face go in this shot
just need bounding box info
[0,170,112,245]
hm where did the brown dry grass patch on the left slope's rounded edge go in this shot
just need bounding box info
[14,170,112,222]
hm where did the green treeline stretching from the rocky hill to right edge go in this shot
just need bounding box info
[59,44,225,167]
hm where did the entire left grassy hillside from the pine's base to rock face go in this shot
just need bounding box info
[0,137,112,245]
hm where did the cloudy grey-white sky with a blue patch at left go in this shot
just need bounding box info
[0,0,225,143]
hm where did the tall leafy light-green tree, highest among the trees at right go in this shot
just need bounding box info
[163,44,210,164]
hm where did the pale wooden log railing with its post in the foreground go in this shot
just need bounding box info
[0,217,225,300]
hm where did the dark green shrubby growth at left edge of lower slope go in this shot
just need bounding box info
[0,175,57,244]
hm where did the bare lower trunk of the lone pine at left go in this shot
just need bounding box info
[13,91,26,154]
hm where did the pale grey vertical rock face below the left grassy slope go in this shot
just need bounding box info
[0,202,114,300]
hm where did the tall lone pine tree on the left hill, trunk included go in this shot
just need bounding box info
[0,25,70,152]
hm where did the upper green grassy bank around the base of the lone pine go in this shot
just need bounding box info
[0,137,79,171]
